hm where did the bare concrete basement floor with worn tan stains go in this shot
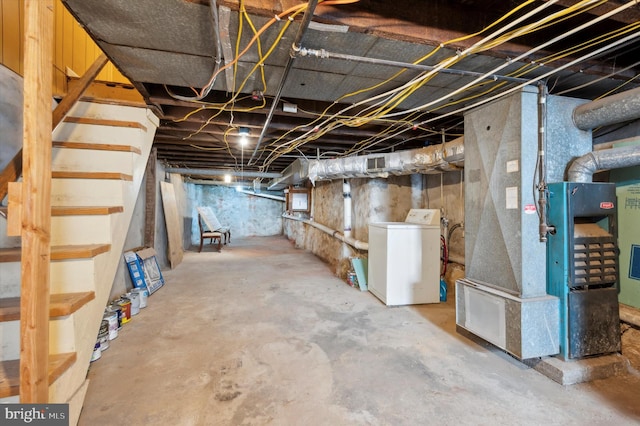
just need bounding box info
[79,237,640,426]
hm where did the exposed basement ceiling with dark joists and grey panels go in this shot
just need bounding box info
[63,0,640,181]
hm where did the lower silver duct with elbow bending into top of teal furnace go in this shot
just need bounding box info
[567,146,640,182]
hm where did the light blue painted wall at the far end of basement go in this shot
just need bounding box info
[185,183,284,245]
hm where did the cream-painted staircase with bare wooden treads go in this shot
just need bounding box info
[0,102,158,424]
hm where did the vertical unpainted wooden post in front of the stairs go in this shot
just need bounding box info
[20,0,54,404]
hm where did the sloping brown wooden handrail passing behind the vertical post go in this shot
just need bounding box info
[0,53,109,200]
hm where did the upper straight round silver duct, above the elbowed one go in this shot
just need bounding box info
[573,87,640,130]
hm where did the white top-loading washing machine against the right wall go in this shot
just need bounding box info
[367,209,440,306]
